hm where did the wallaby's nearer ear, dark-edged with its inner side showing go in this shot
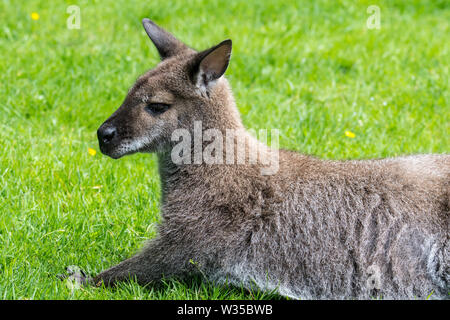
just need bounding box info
[192,39,231,91]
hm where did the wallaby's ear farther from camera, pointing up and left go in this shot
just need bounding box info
[142,18,188,60]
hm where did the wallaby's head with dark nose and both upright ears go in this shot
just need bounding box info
[97,19,236,159]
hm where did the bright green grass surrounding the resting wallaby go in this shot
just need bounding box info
[0,0,450,299]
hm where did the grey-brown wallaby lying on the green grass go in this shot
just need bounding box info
[71,19,450,299]
